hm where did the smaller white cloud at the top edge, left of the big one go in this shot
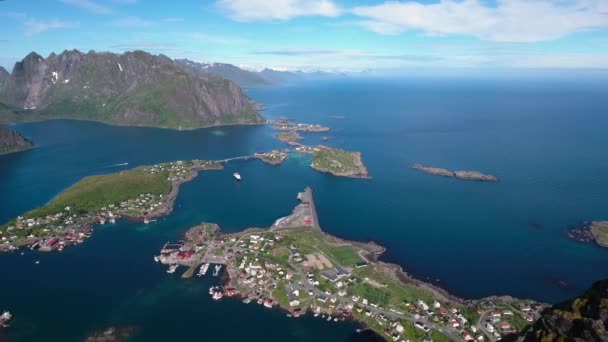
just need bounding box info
[216,0,341,21]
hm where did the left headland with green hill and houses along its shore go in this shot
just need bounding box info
[0,160,223,252]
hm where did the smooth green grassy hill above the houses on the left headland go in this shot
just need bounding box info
[24,168,171,217]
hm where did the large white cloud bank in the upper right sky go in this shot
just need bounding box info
[352,0,608,42]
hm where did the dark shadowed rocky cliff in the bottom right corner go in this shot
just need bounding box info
[519,279,608,342]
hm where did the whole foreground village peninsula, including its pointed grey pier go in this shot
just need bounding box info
[154,189,545,341]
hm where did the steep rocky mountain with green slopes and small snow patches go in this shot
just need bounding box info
[0,50,263,128]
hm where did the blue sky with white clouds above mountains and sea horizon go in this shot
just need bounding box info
[0,0,608,71]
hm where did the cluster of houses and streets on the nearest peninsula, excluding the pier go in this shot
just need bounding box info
[157,220,548,341]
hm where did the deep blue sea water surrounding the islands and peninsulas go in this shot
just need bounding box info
[0,79,608,341]
